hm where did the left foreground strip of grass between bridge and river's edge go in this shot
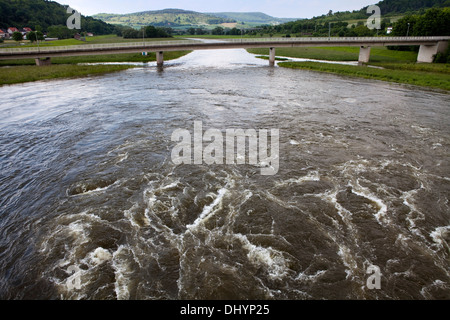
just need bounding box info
[0,65,132,85]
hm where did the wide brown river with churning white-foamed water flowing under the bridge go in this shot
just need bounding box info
[0,50,450,299]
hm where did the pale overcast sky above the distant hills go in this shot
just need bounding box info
[57,0,372,18]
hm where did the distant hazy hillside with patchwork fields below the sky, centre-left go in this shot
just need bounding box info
[94,9,235,28]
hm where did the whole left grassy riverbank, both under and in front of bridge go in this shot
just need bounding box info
[0,51,190,86]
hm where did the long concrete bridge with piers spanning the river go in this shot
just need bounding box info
[0,37,450,66]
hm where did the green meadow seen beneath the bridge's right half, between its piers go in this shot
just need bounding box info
[247,47,417,62]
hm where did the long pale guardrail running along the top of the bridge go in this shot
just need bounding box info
[0,37,450,54]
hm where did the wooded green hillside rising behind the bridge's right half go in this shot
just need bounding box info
[260,0,450,37]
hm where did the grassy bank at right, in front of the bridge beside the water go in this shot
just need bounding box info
[278,62,450,91]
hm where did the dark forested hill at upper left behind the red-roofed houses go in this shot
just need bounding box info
[0,0,115,34]
